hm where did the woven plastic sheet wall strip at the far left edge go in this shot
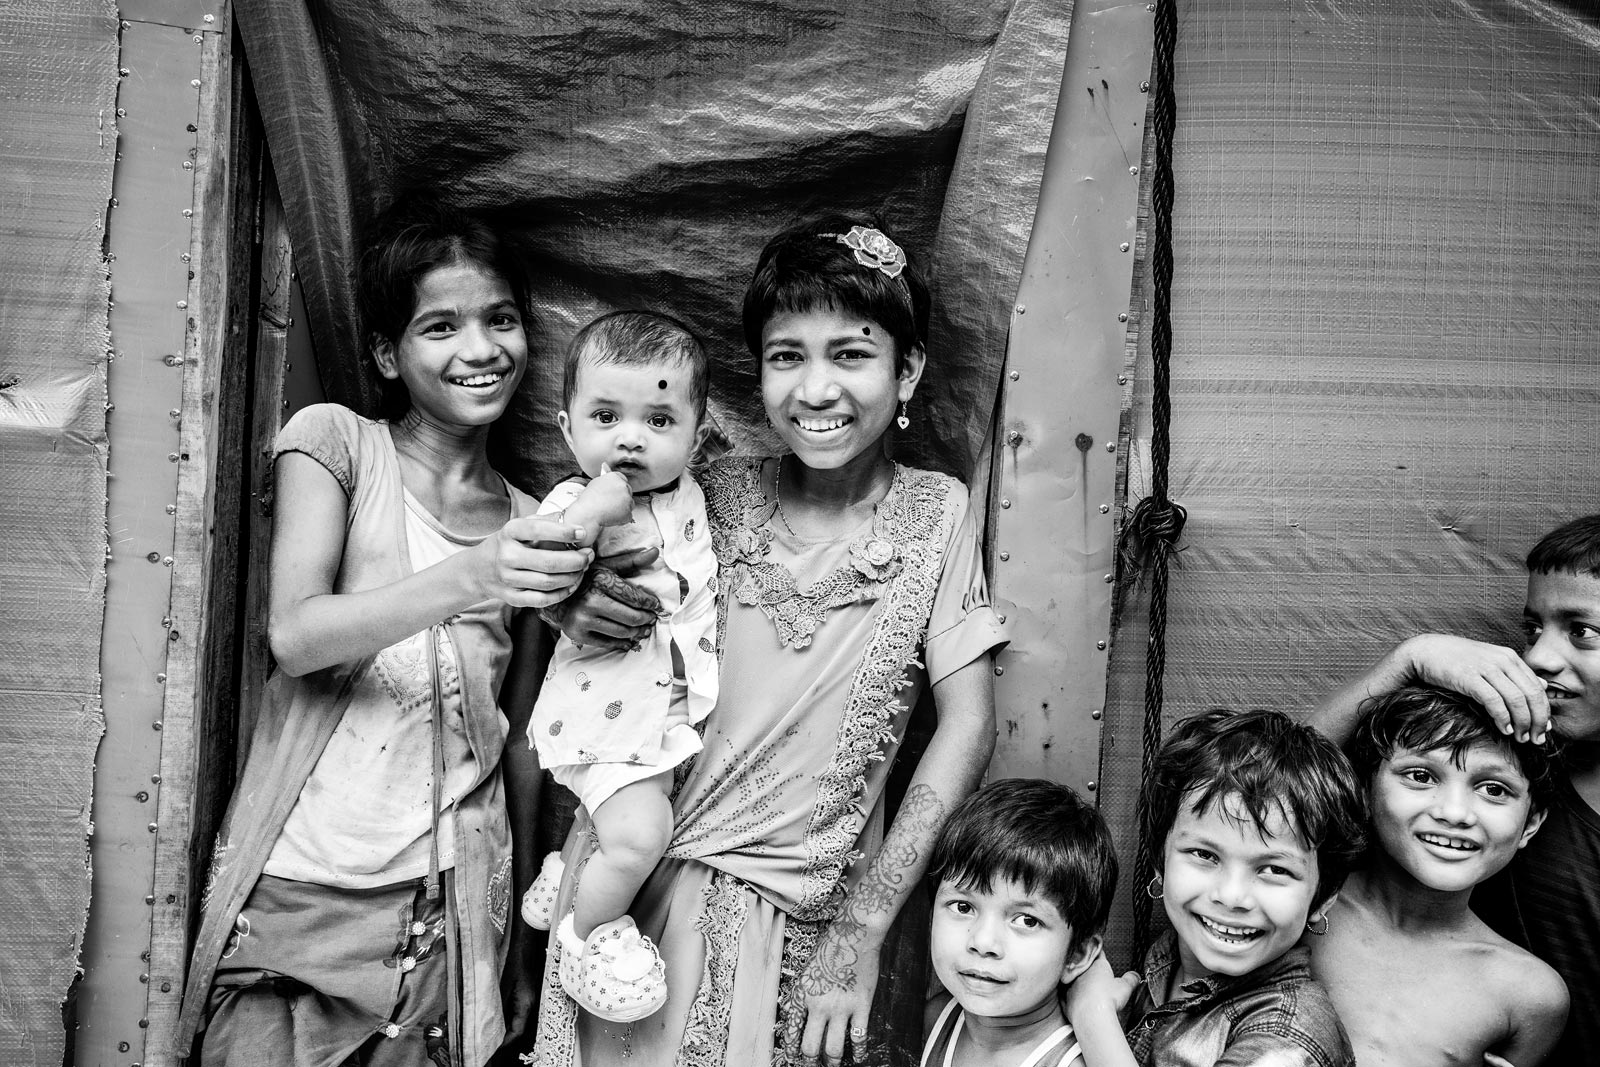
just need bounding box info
[0,0,117,1064]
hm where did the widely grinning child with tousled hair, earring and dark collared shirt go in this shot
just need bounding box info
[1066,710,1365,1067]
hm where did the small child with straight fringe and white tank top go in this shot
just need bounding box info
[922,779,1117,1067]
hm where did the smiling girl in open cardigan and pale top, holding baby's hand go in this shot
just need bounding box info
[179,200,590,1067]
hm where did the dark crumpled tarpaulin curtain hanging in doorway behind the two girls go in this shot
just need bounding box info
[238,0,1072,491]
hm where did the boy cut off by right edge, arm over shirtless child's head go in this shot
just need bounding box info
[1315,515,1600,1067]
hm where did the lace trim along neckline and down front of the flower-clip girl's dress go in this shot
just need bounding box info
[702,459,960,920]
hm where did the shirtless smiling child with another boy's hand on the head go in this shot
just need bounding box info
[1306,686,1566,1067]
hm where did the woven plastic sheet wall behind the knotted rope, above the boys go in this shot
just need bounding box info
[1102,0,1600,965]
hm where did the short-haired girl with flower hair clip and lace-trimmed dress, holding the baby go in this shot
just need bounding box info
[533,218,1003,1067]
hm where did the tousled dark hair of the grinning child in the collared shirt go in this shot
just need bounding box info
[1144,710,1366,910]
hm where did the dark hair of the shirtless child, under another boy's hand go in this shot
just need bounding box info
[1344,685,1555,811]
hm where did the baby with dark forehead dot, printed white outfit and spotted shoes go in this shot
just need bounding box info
[522,310,717,1022]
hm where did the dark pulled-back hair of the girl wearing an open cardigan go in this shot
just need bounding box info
[355,192,533,419]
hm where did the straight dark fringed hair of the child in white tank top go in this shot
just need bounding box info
[928,777,1117,952]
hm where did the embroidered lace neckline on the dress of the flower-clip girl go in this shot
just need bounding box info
[712,464,922,648]
